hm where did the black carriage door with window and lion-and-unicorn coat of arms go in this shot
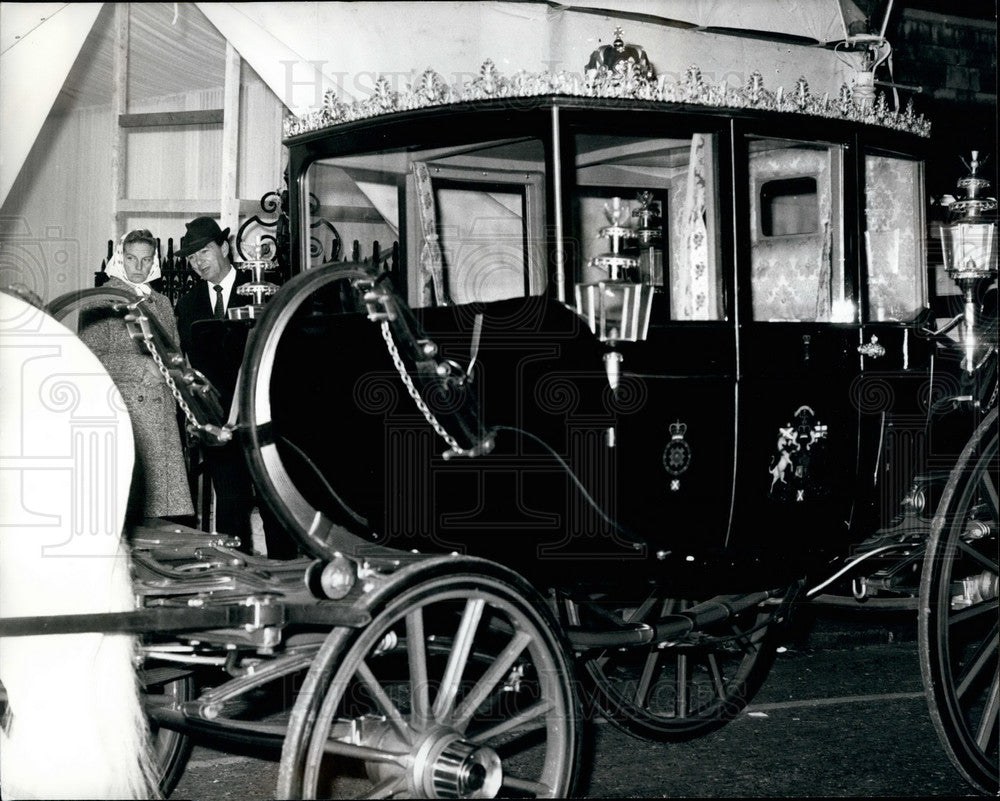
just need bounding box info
[732,137,859,552]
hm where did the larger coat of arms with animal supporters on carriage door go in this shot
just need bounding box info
[768,406,829,502]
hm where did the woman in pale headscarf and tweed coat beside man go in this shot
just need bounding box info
[79,230,194,523]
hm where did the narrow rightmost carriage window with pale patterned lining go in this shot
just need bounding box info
[864,155,927,321]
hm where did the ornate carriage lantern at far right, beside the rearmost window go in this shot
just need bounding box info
[941,150,997,372]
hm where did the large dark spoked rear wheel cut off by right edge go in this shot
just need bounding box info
[918,409,1000,794]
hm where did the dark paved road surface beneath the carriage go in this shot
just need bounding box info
[173,615,984,801]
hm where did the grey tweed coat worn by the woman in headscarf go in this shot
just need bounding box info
[79,277,194,520]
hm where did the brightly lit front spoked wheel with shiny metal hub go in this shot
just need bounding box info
[278,566,580,798]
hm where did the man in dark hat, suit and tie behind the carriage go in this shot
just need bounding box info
[175,217,297,559]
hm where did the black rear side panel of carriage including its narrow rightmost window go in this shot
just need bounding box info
[855,152,932,531]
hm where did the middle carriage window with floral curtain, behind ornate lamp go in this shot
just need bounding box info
[573,133,725,320]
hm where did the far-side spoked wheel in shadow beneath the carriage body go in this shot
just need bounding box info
[570,588,775,742]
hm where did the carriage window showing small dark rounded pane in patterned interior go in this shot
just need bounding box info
[749,139,855,322]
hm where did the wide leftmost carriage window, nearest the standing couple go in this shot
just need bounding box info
[308,139,546,307]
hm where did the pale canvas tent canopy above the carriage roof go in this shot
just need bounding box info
[0,0,862,202]
